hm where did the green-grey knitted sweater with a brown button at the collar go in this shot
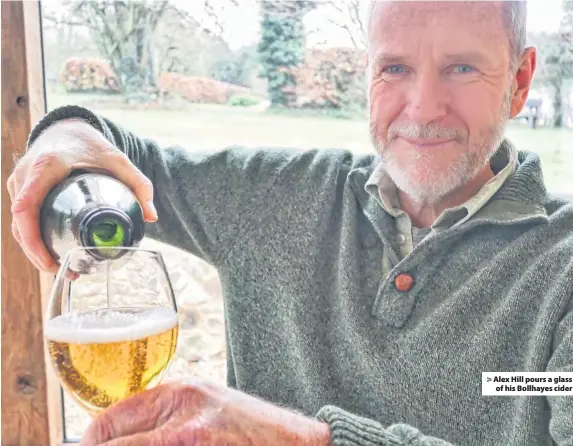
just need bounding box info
[30,106,573,446]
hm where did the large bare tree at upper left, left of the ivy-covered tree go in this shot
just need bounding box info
[43,0,239,97]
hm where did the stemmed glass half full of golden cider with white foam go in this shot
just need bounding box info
[44,247,179,417]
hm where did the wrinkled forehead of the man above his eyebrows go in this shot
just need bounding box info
[368,0,509,51]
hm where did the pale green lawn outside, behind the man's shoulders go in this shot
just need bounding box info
[48,94,573,195]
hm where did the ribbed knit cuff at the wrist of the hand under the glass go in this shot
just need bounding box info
[316,406,403,446]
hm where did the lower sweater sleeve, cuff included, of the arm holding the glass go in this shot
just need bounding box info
[316,406,454,446]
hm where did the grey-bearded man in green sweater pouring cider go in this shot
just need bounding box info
[8,2,573,446]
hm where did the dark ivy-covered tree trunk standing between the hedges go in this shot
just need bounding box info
[258,0,315,107]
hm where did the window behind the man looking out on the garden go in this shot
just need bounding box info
[31,0,573,440]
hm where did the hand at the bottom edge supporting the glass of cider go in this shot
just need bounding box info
[80,383,331,446]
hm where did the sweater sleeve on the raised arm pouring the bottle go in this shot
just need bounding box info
[28,106,288,265]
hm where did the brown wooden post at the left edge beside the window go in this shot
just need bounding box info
[1,0,63,446]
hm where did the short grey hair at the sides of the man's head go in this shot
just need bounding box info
[367,0,527,71]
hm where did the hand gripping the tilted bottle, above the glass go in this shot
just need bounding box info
[7,119,157,273]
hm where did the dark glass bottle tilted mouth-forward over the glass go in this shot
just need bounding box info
[40,170,145,274]
